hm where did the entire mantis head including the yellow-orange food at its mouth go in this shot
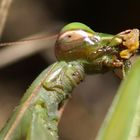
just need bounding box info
[55,22,139,76]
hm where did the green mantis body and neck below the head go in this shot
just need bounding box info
[0,61,84,140]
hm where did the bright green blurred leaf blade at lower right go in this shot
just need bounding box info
[96,59,140,140]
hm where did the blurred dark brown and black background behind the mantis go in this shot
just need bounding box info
[0,0,140,140]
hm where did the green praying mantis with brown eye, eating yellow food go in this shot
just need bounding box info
[0,22,139,140]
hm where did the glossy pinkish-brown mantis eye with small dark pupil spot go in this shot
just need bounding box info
[55,30,94,59]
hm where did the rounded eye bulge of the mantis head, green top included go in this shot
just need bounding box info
[55,22,100,61]
